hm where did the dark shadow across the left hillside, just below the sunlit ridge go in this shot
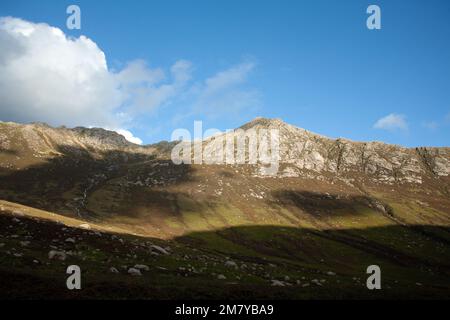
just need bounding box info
[0,145,192,216]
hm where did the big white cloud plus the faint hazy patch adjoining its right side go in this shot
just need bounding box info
[0,17,191,128]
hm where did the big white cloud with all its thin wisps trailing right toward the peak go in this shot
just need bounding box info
[0,17,259,143]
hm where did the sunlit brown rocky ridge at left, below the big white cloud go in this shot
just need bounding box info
[0,122,154,169]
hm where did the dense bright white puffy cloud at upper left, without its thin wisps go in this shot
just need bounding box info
[0,18,121,125]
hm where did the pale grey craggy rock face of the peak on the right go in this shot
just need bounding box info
[199,118,450,184]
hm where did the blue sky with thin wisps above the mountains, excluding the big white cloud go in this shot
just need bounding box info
[0,0,450,146]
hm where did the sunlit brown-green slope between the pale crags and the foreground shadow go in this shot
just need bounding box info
[87,161,450,237]
